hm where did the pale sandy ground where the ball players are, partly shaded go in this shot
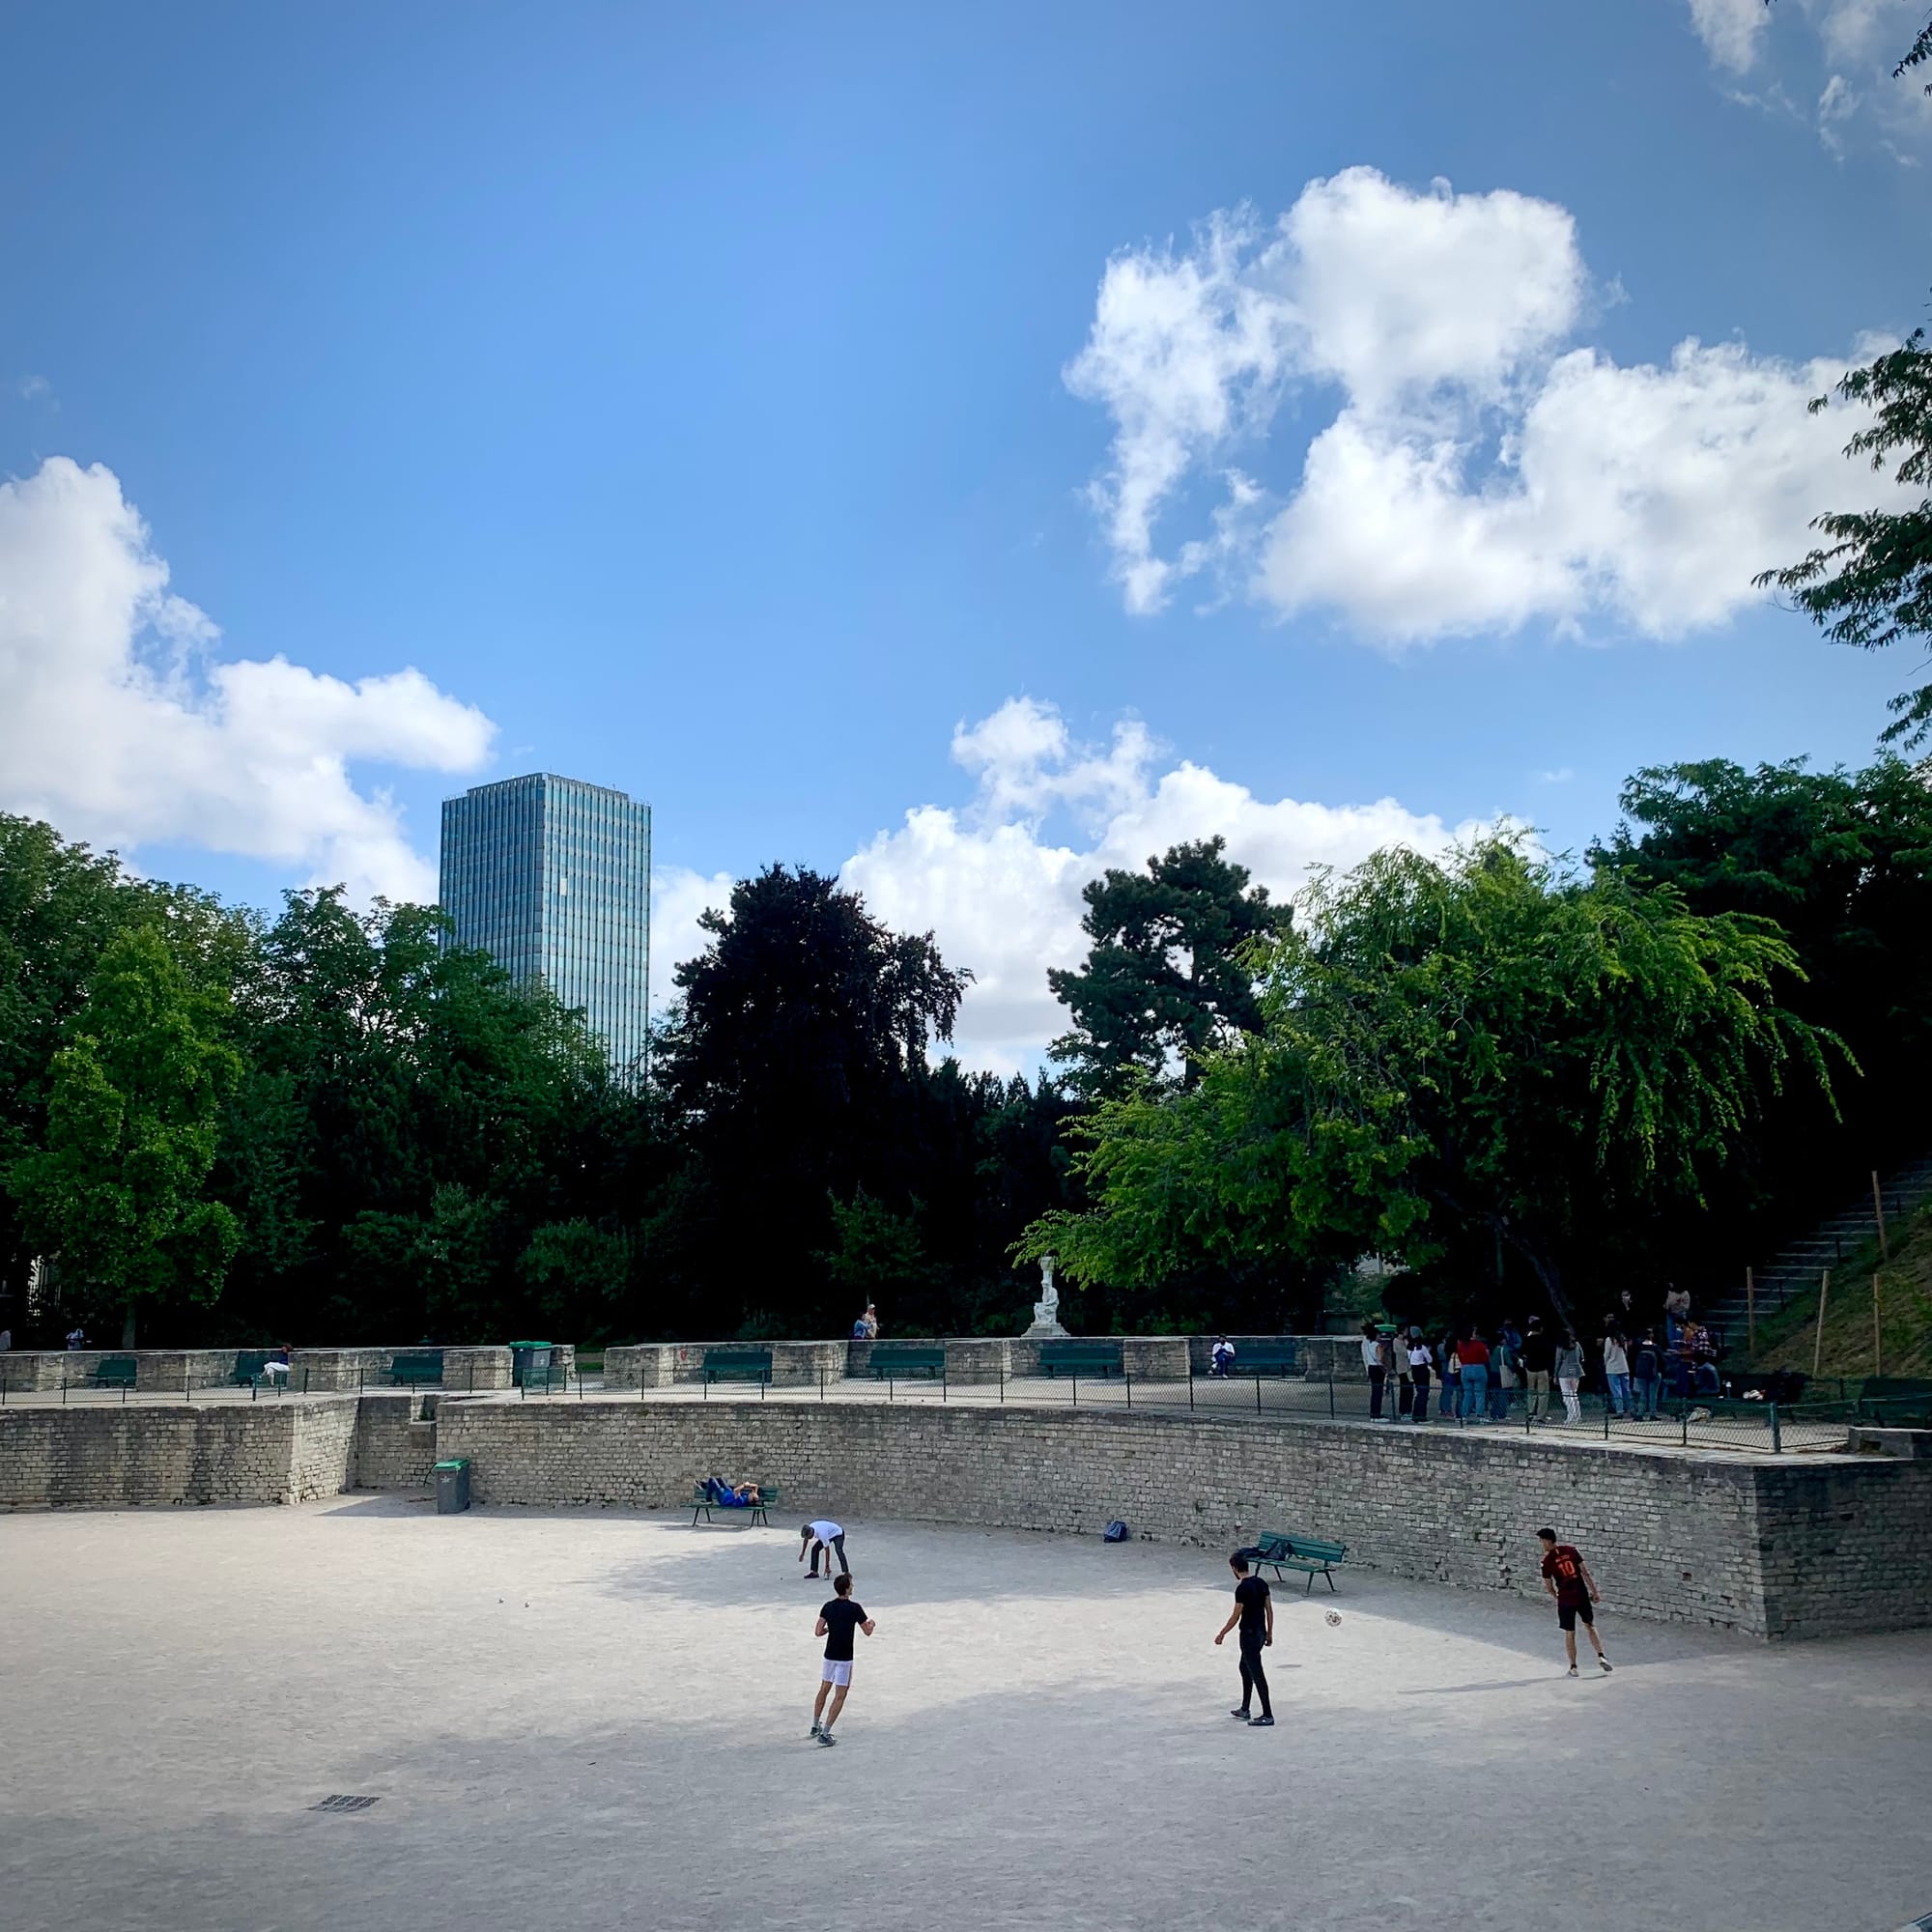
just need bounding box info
[0,1495,1932,1932]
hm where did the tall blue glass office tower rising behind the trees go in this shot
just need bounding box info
[440,771,651,1074]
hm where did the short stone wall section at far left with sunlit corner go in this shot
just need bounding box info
[0,1399,355,1509]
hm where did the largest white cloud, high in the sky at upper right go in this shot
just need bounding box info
[1066,168,1917,643]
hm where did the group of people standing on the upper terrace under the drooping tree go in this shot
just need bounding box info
[1362,1316,1692,1424]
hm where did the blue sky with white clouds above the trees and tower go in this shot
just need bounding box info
[0,0,1932,1065]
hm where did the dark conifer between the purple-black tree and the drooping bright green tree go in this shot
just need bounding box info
[1047,838,1279,1097]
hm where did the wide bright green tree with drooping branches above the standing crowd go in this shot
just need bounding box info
[1022,840,1824,1337]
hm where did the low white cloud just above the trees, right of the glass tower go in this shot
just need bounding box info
[840,697,1478,1072]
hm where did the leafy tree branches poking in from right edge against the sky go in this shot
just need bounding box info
[1756,321,1932,748]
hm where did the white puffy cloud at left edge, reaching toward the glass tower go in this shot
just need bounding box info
[0,456,495,900]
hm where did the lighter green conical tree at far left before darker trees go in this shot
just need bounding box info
[8,925,242,1347]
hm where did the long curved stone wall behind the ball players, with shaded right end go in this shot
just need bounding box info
[440,1401,1932,1636]
